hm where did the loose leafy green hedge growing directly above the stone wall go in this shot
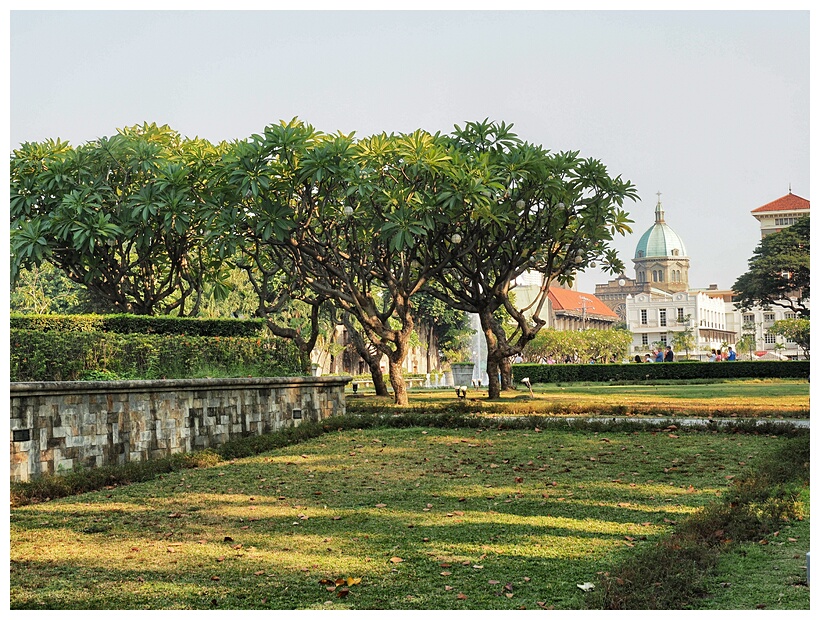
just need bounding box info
[10,329,304,381]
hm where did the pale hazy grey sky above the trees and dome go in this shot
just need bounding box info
[9,3,811,292]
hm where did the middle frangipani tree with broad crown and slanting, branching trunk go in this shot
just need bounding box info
[208,119,470,404]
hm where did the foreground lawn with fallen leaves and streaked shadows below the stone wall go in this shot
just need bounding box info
[9,426,809,610]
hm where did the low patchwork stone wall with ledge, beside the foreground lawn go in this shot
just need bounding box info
[10,377,350,481]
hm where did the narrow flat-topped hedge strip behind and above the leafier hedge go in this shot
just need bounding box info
[10,314,265,338]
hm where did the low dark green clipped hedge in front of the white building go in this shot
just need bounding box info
[513,360,809,383]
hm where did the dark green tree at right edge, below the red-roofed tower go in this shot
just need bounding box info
[732,215,811,319]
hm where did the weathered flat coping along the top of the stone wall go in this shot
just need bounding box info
[10,376,353,398]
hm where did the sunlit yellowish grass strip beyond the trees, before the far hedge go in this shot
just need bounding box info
[374,379,809,418]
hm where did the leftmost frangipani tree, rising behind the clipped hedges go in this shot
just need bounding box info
[9,123,224,316]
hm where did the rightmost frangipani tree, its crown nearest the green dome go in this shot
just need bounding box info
[420,121,637,398]
